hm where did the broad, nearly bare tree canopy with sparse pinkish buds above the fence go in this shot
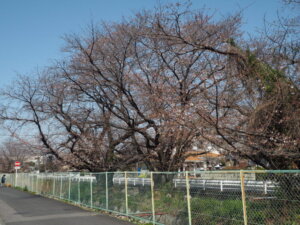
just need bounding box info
[1,4,300,171]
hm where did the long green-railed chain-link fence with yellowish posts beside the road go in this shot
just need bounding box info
[1,170,300,225]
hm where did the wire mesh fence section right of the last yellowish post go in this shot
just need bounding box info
[245,171,300,225]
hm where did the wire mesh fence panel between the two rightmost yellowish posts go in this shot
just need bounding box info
[189,172,244,225]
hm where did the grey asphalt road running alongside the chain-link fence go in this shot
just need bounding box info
[0,187,132,225]
